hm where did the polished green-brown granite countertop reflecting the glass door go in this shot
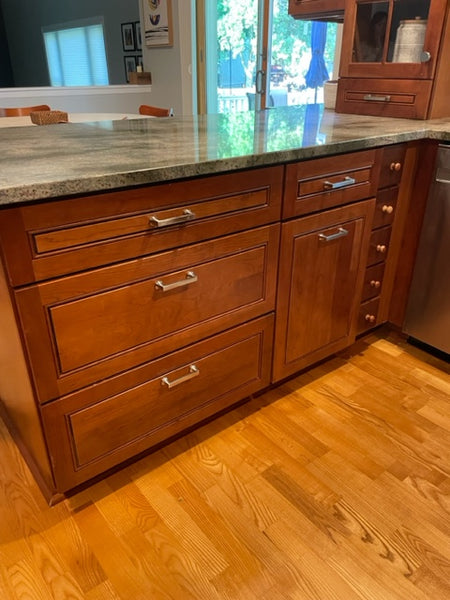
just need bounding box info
[0,105,450,205]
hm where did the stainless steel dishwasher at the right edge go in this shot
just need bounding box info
[404,145,450,358]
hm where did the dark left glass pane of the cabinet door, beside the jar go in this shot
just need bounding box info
[353,2,389,62]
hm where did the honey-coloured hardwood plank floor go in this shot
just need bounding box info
[0,331,450,600]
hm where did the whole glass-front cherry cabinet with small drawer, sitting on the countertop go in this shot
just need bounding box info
[336,0,450,119]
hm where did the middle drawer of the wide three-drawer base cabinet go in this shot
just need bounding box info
[16,225,279,402]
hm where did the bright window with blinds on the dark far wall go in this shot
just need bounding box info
[42,17,109,86]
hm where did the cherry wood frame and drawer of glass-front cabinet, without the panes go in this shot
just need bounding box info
[336,0,450,119]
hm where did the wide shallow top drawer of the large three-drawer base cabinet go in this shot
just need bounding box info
[0,166,283,285]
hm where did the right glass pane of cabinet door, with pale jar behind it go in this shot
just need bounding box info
[388,0,430,63]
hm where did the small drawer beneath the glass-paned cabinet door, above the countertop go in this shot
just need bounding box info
[336,77,431,119]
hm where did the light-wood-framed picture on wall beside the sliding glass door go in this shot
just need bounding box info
[141,0,173,48]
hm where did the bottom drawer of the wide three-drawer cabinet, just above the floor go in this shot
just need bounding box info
[42,315,273,492]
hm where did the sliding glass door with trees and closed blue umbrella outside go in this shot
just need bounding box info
[197,0,337,113]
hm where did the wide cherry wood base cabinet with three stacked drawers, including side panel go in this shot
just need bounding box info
[0,166,284,500]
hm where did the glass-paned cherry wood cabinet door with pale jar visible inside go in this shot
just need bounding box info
[340,0,447,79]
